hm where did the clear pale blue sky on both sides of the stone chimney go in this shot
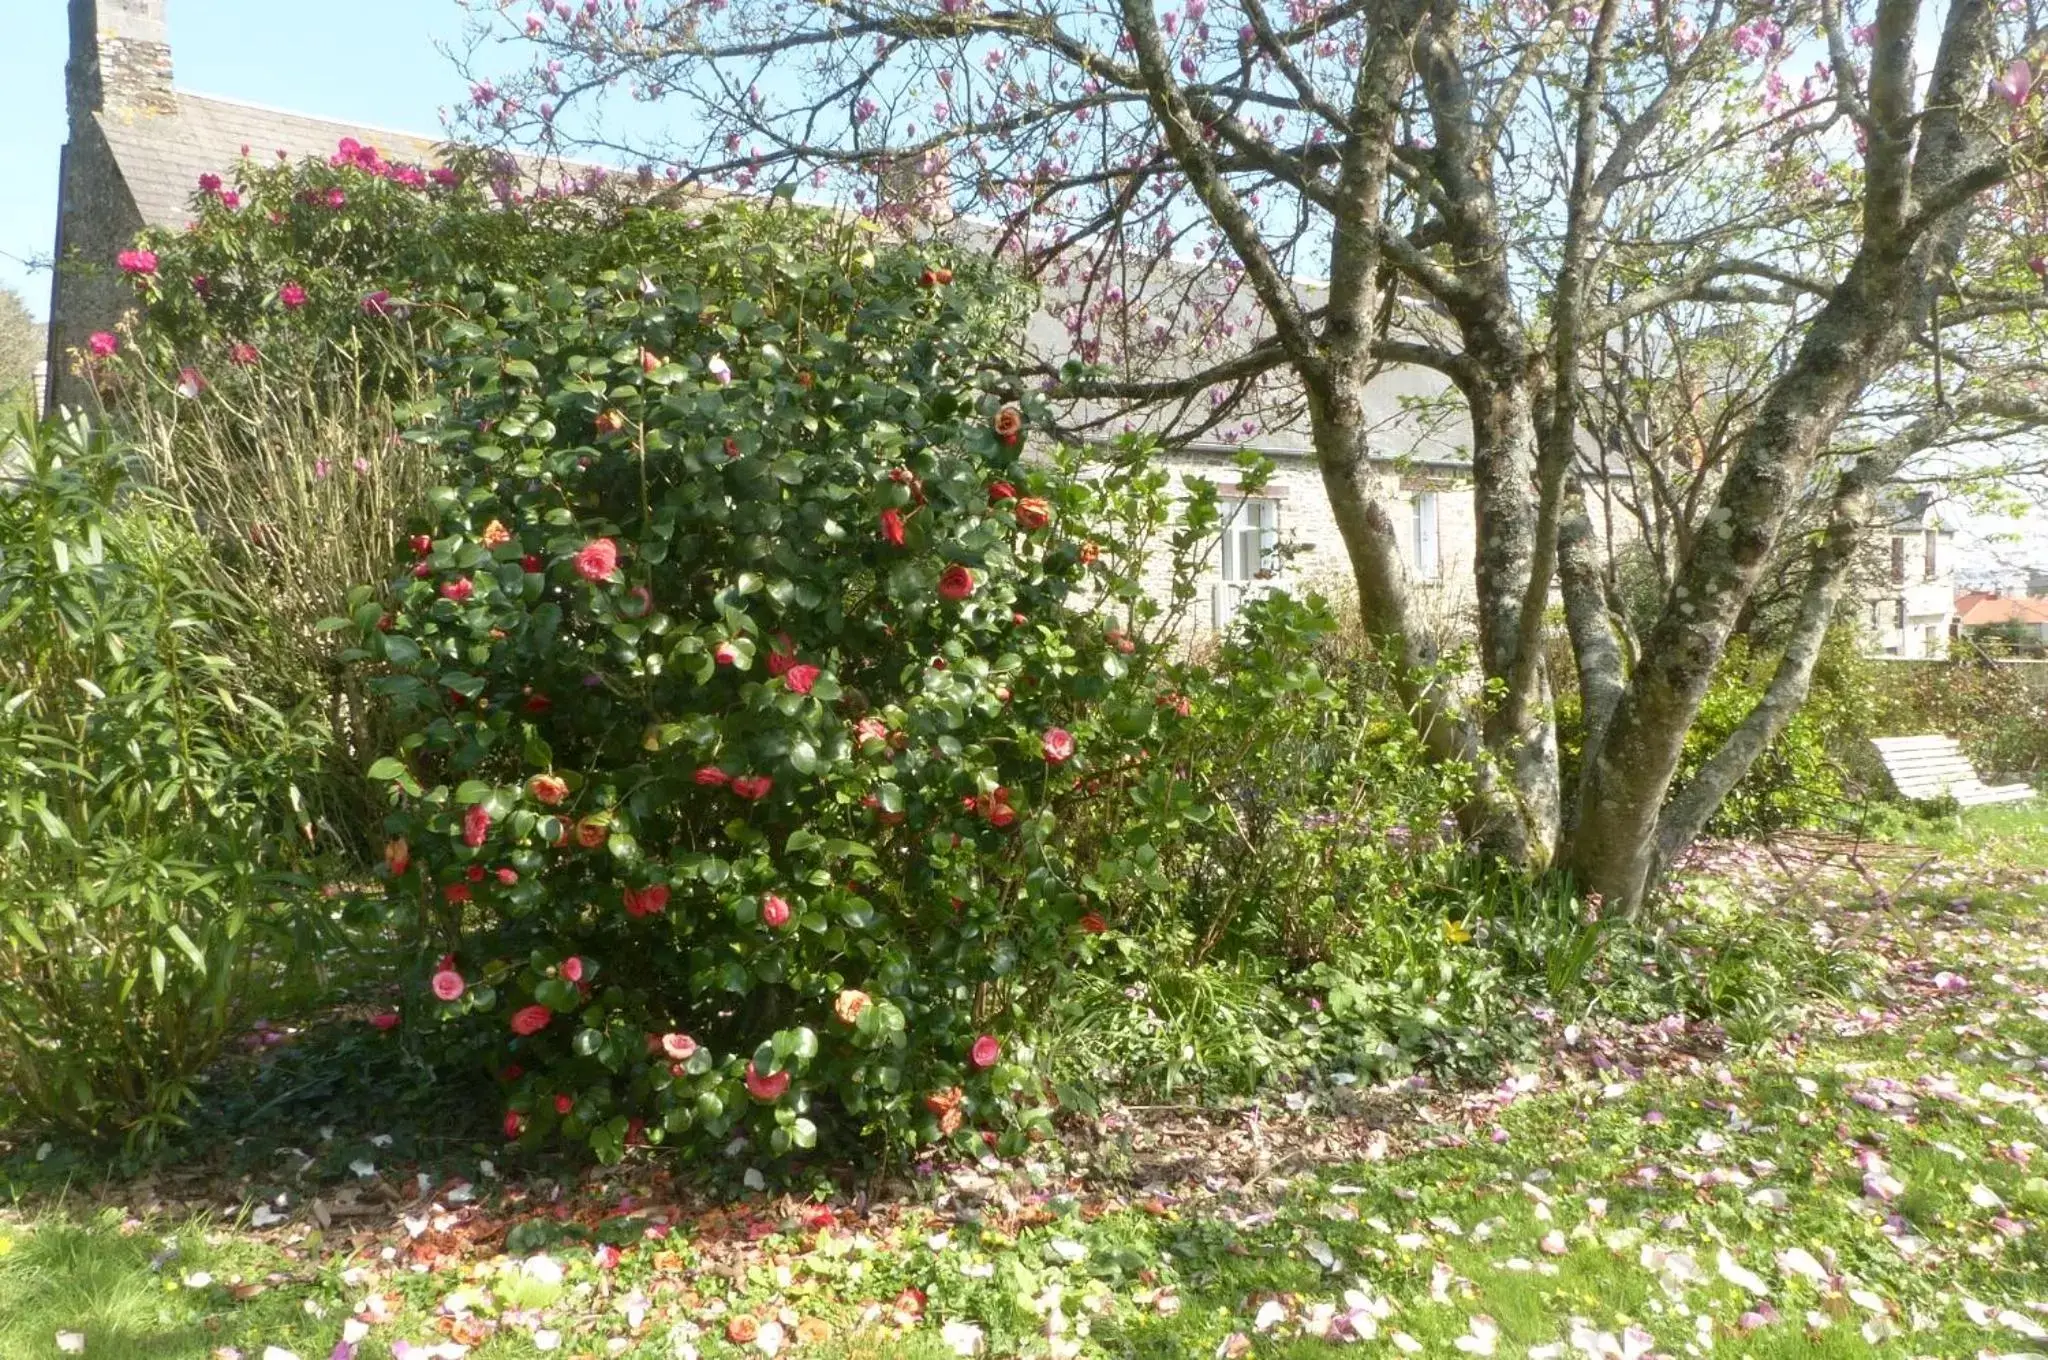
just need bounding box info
[0,0,467,317]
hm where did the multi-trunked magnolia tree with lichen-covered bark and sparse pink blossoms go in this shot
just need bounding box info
[467,0,2048,905]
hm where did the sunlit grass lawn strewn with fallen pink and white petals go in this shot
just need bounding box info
[0,811,2048,1360]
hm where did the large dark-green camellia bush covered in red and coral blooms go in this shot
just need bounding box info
[346,207,1180,1159]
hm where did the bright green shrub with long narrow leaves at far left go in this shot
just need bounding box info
[0,424,331,1143]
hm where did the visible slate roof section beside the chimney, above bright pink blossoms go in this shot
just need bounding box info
[94,90,442,227]
